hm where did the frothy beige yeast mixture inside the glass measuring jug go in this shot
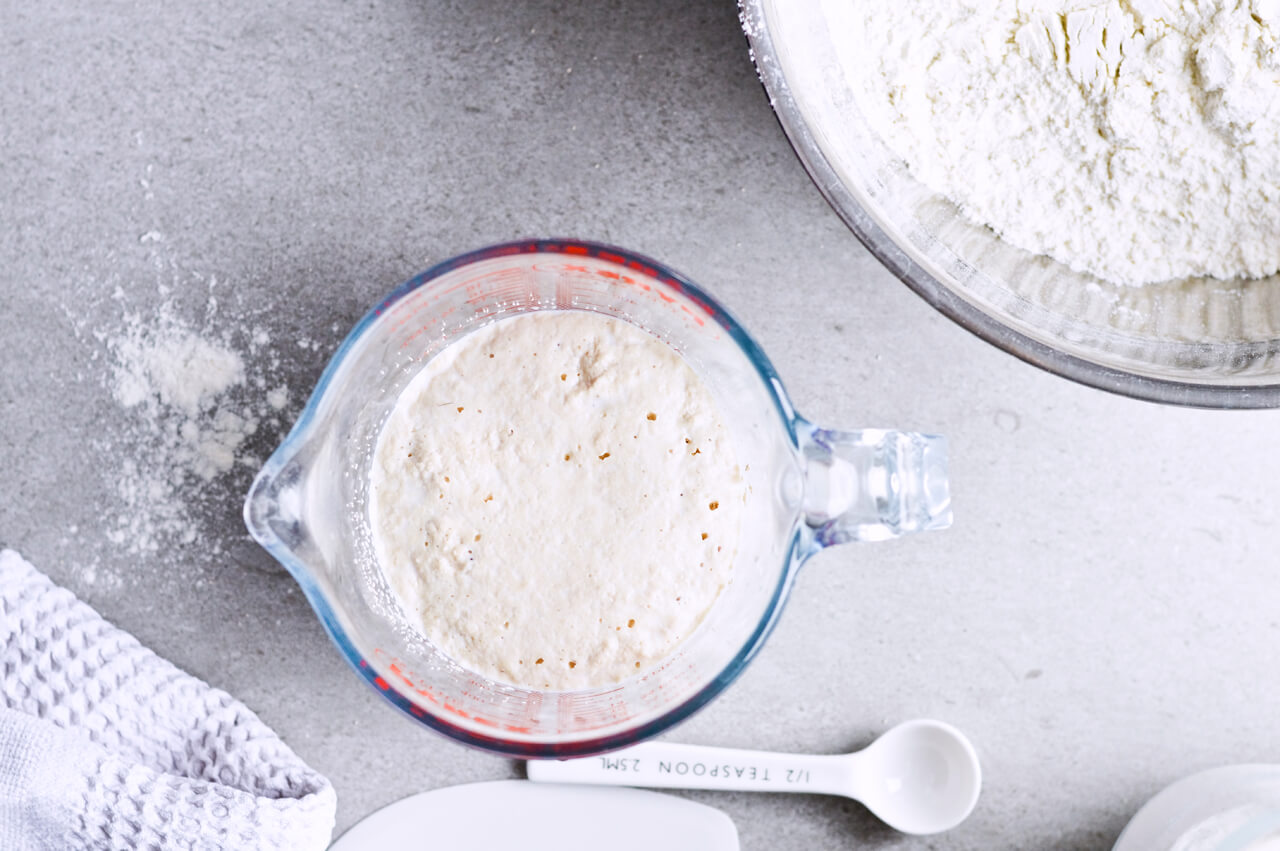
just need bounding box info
[370,311,746,690]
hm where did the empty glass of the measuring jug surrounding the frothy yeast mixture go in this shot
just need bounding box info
[244,241,951,758]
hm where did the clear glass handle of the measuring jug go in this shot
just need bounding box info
[800,426,951,546]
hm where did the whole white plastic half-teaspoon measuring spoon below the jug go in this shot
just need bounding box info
[529,719,982,834]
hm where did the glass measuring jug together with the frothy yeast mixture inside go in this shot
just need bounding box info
[244,241,951,758]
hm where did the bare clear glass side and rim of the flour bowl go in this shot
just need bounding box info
[741,0,1280,408]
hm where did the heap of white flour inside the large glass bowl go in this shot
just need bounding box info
[824,0,1280,284]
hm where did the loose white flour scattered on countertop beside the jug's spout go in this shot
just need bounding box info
[48,256,342,587]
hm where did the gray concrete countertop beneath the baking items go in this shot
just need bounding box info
[0,0,1280,850]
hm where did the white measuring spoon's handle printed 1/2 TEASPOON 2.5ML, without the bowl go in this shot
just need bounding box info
[529,742,852,795]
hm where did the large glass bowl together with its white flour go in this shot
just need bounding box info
[742,0,1280,408]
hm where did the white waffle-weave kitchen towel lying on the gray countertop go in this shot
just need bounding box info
[0,550,335,851]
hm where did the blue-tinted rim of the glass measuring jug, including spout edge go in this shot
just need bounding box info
[244,239,813,759]
